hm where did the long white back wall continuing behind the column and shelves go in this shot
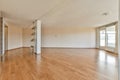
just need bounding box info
[23,27,95,48]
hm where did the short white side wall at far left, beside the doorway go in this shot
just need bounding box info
[8,25,23,50]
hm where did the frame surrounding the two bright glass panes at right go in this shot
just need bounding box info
[96,21,118,53]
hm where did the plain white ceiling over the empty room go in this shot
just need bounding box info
[0,0,119,27]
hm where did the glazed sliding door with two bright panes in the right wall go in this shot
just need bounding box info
[99,24,117,52]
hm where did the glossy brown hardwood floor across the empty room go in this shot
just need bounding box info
[0,48,118,80]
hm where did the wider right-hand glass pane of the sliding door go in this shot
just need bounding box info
[106,26,116,47]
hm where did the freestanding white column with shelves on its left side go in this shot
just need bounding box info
[35,20,41,54]
